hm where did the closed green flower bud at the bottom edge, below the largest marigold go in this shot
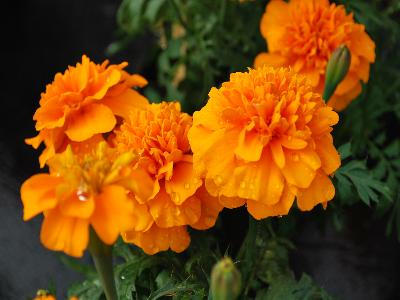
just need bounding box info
[211,257,242,300]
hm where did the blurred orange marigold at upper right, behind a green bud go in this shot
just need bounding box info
[255,0,375,111]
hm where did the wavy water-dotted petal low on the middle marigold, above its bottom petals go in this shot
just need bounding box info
[148,187,201,228]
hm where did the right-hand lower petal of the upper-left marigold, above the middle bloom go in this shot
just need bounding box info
[101,89,149,120]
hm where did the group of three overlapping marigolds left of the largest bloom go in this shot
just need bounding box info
[21,56,222,256]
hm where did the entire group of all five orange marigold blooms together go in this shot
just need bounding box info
[21,0,375,256]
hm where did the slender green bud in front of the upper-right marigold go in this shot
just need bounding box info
[322,45,351,101]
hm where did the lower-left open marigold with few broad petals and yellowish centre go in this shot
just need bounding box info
[21,142,153,257]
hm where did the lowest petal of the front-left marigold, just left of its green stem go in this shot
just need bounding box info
[40,209,89,257]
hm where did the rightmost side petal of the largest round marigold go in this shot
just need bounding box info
[315,134,340,175]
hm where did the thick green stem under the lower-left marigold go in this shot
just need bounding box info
[89,228,118,300]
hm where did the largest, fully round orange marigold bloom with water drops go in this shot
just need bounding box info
[189,66,340,219]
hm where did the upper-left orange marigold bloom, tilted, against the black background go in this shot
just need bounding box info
[26,55,147,167]
